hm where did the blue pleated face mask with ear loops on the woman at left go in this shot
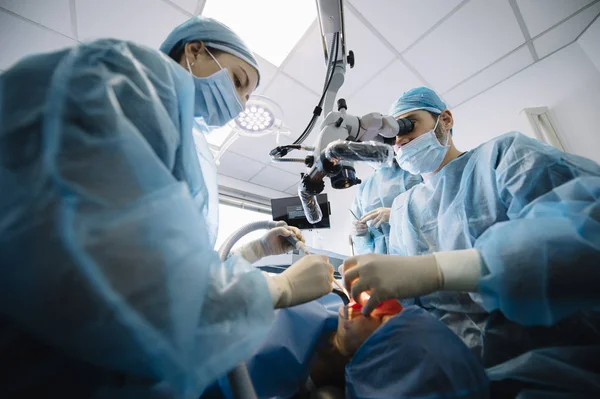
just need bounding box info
[185,49,244,127]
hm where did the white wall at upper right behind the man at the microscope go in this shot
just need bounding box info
[452,43,600,162]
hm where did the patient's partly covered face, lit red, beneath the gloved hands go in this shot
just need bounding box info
[334,300,402,356]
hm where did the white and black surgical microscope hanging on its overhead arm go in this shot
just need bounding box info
[270,0,414,224]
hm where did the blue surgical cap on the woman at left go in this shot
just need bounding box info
[160,16,260,81]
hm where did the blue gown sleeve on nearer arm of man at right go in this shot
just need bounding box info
[475,134,600,325]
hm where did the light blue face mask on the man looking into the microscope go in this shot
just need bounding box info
[396,117,450,175]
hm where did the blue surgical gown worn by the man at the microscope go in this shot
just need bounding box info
[390,133,600,396]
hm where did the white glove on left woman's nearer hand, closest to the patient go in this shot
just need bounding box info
[265,255,334,309]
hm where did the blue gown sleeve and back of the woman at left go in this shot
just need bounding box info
[0,40,273,398]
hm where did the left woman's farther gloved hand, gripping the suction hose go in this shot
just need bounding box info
[233,222,305,263]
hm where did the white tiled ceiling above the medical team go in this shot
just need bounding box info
[0,0,600,194]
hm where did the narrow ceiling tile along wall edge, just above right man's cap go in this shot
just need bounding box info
[444,46,533,106]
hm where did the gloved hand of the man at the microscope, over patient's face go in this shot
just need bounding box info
[344,254,443,316]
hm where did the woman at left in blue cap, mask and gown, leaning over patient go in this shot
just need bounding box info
[0,17,333,398]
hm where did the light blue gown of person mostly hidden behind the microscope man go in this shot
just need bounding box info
[352,162,423,255]
